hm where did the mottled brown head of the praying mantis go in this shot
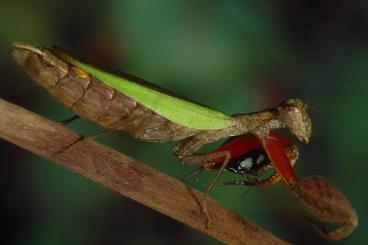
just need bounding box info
[277,98,312,144]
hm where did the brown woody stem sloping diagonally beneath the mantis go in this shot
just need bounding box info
[0,98,286,244]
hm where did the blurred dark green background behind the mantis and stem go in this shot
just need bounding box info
[0,0,368,244]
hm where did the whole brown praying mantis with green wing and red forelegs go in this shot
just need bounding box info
[13,42,357,239]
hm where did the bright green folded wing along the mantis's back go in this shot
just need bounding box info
[57,50,236,129]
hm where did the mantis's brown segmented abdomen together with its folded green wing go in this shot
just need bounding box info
[13,42,235,141]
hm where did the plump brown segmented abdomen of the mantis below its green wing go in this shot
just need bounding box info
[13,43,198,141]
